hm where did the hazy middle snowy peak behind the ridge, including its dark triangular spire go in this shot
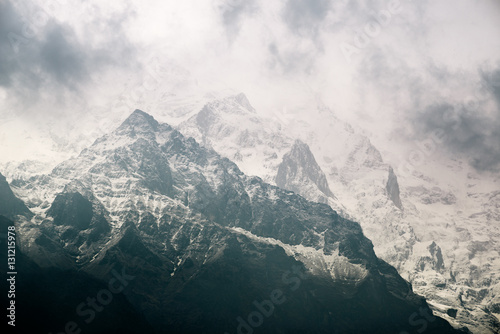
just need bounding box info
[178,93,348,216]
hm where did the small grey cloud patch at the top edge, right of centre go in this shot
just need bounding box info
[283,0,331,39]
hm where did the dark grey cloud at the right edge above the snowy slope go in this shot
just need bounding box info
[413,73,500,171]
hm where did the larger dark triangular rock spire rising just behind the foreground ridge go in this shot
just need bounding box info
[276,140,333,203]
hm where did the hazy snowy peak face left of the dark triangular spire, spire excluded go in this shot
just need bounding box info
[178,94,293,182]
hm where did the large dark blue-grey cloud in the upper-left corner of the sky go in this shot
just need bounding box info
[0,1,134,102]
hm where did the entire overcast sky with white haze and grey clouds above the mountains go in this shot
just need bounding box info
[0,0,500,170]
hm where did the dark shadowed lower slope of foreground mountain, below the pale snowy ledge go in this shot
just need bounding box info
[82,222,455,333]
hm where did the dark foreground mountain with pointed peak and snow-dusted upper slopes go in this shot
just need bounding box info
[6,110,459,333]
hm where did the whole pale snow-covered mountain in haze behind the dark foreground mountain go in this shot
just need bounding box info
[178,92,500,334]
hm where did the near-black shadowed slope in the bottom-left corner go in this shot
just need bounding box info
[0,216,154,334]
